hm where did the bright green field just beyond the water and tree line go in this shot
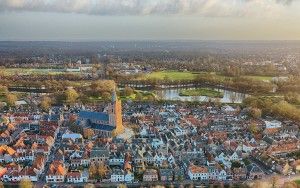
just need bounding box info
[141,71,201,80]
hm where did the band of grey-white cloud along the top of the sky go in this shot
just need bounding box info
[0,0,293,17]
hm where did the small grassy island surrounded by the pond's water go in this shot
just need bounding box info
[179,88,223,98]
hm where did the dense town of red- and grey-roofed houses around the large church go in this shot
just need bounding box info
[0,86,300,185]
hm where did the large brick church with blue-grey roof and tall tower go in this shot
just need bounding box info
[78,92,124,138]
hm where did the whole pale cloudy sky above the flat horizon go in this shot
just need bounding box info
[0,0,300,41]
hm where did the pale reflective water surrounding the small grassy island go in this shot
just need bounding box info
[155,88,249,103]
